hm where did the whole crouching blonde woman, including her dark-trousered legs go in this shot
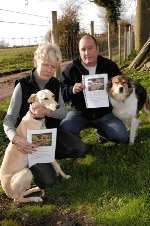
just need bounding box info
[3,42,87,188]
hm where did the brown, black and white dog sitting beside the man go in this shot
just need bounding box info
[107,75,150,144]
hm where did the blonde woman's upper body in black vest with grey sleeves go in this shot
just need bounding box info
[3,43,65,153]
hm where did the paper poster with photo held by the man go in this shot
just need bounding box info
[82,74,109,108]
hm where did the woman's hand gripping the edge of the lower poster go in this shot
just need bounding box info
[12,135,39,154]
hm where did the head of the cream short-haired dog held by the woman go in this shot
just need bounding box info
[28,89,58,111]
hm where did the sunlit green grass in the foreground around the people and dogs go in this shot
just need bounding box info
[0,70,150,226]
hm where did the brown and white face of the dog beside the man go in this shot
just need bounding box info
[107,75,133,101]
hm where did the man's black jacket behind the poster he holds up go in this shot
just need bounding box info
[60,55,121,120]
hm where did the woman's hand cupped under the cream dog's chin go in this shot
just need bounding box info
[30,103,50,119]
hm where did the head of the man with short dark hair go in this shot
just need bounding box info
[79,37,98,66]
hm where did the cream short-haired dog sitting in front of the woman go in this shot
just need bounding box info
[0,89,70,202]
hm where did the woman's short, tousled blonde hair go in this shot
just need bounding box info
[34,42,62,67]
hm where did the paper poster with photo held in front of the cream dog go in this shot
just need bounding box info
[27,128,57,167]
